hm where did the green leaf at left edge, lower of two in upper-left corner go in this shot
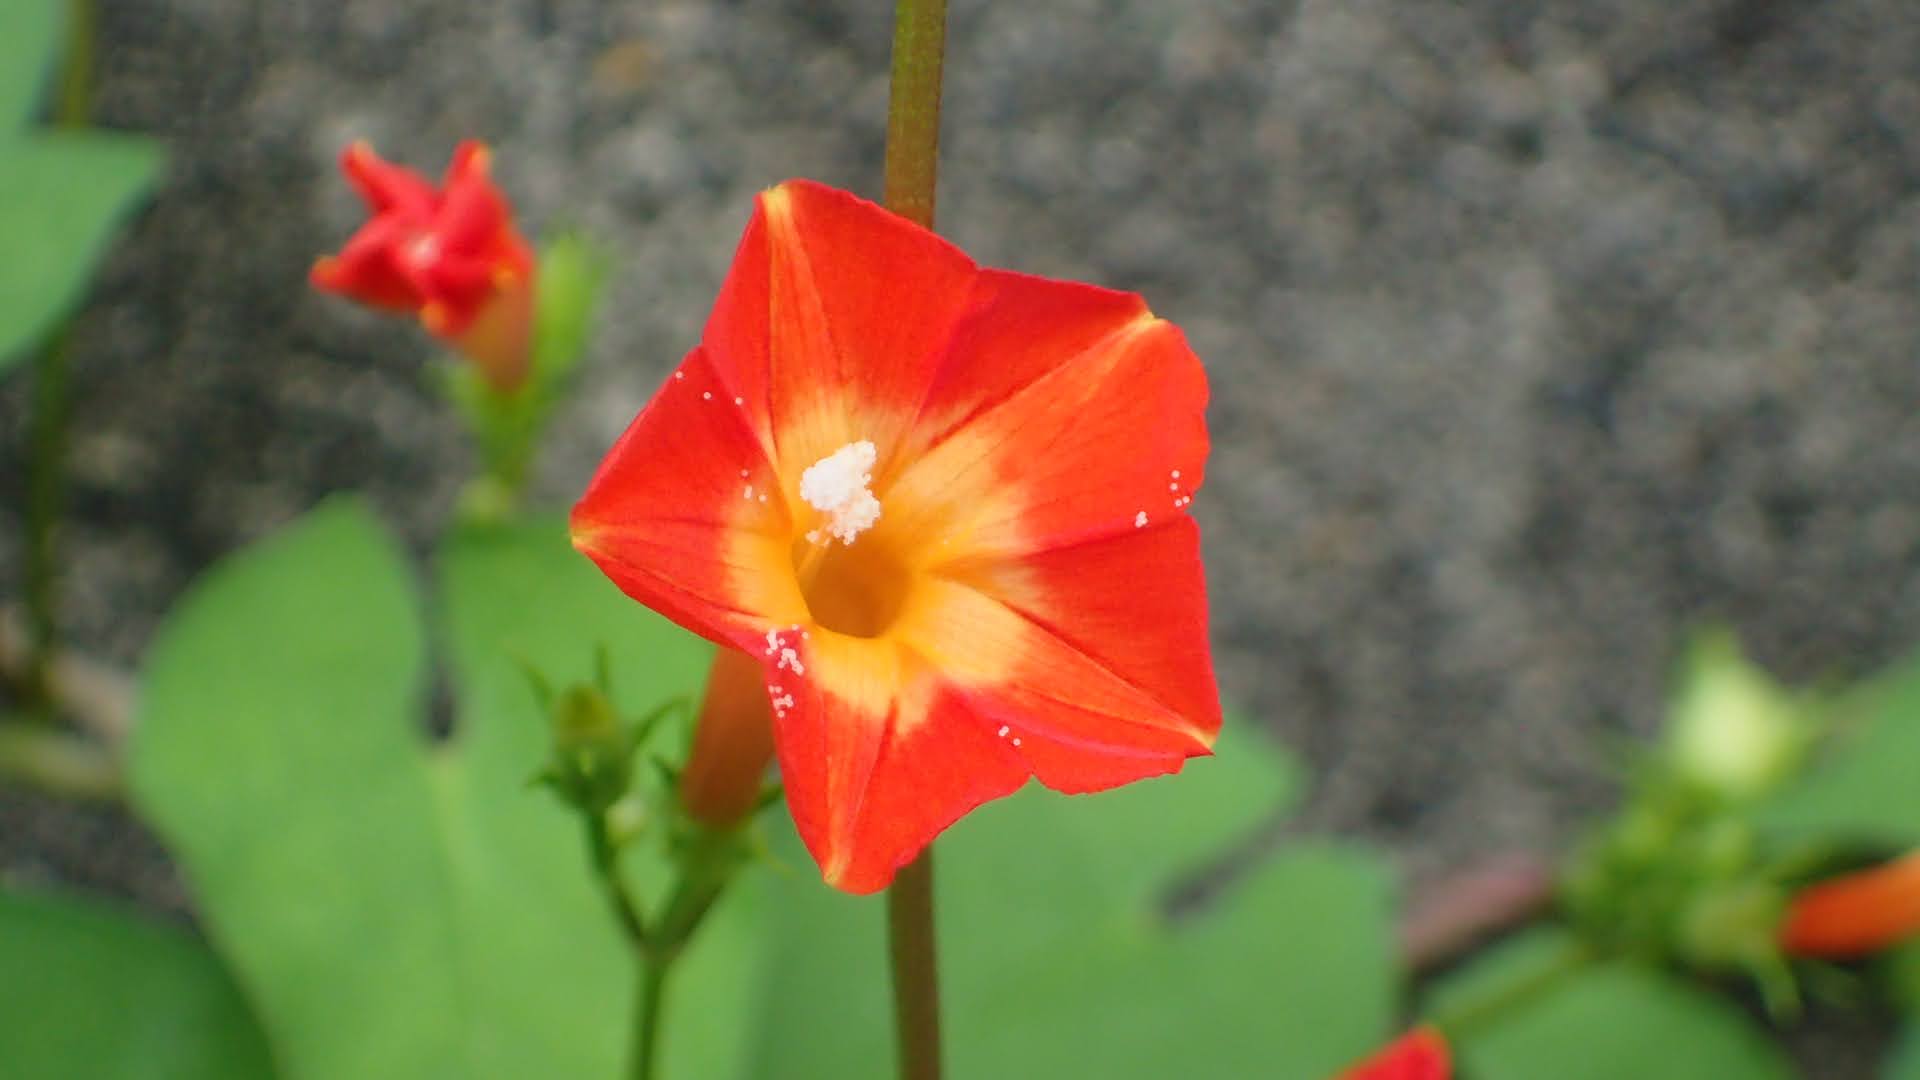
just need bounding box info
[0,131,159,371]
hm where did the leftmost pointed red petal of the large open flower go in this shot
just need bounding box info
[570,348,806,650]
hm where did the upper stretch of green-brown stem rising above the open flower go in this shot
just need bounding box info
[887,0,947,229]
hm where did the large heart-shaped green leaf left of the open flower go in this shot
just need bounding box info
[131,503,755,1080]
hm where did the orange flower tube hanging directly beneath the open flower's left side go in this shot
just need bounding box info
[680,648,774,828]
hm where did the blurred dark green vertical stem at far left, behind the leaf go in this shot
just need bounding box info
[21,0,94,713]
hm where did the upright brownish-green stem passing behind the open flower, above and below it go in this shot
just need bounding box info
[885,0,947,1080]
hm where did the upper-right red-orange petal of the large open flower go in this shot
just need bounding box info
[883,282,1208,559]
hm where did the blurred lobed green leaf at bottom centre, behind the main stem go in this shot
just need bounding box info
[747,724,1398,1080]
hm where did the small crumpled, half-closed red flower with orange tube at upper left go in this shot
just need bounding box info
[309,142,534,392]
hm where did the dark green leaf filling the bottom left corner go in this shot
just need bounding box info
[0,892,273,1080]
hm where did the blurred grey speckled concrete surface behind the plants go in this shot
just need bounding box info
[0,0,1920,1068]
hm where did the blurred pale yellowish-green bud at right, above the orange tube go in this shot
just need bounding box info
[1665,630,1811,801]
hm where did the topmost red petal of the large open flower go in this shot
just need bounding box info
[705,181,979,494]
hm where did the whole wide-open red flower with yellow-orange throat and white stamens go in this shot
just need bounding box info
[572,181,1221,892]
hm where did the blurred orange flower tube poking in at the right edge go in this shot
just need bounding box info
[1780,851,1920,959]
